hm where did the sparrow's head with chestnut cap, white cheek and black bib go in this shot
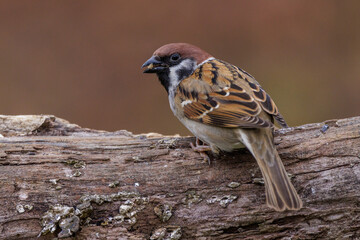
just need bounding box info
[142,43,212,92]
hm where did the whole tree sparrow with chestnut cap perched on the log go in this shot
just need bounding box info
[142,43,302,211]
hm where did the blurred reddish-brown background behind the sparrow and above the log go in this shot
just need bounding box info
[0,0,360,134]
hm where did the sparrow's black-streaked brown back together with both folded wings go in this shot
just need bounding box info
[176,59,287,128]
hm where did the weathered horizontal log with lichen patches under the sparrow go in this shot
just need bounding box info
[0,116,360,239]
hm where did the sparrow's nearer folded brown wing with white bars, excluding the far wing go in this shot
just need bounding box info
[176,60,272,128]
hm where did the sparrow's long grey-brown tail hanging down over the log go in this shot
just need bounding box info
[239,128,302,211]
